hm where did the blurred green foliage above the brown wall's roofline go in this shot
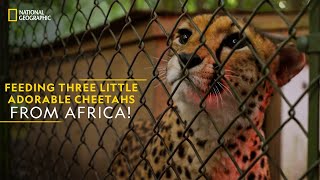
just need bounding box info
[9,0,308,48]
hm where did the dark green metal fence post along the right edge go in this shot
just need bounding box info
[308,0,320,180]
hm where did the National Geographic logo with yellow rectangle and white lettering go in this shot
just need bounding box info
[8,8,51,22]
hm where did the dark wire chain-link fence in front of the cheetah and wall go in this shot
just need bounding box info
[0,0,320,179]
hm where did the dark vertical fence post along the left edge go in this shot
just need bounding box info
[0,0,9,179]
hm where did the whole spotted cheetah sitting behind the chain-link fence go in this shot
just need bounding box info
[108,15,306,180]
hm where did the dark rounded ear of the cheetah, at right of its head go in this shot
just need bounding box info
[276,44,306,86]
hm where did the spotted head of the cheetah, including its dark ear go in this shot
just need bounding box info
[167,15,306,116]
